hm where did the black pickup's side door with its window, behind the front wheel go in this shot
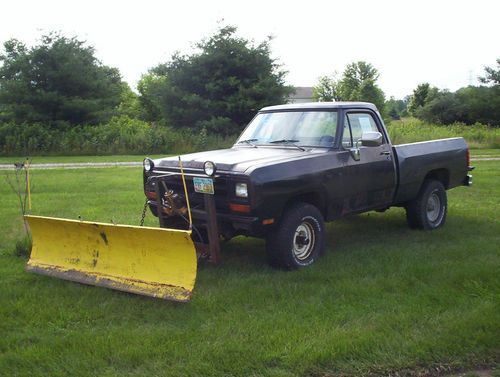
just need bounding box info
[342,110,396,213]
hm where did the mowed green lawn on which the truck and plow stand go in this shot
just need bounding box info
[0,157,500,376]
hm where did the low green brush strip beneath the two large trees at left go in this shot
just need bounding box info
[0,116,236,156]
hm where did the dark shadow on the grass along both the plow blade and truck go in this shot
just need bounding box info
[17,208,495,306]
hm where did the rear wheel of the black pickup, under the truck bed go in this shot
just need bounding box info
[406,180,448,230]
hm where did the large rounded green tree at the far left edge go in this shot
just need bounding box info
[0,33,123,125]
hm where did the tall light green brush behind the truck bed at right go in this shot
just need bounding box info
[387,118,500,148]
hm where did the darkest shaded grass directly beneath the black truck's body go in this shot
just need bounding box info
[214,208,484,271]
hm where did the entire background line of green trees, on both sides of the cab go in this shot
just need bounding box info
[0,26,500,153]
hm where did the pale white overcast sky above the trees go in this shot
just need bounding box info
[0,0,500,98]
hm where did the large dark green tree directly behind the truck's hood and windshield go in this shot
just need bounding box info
[138,26,291,135]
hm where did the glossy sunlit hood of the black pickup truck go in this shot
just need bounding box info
[154,146,327,173]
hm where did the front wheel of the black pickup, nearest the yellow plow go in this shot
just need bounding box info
[266,203,325,269]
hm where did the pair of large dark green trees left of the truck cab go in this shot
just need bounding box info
[0,26,292,135]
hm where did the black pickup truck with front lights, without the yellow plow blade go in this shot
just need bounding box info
[144,102,472,268]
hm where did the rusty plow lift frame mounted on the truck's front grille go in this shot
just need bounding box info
[146,173,220,264]
